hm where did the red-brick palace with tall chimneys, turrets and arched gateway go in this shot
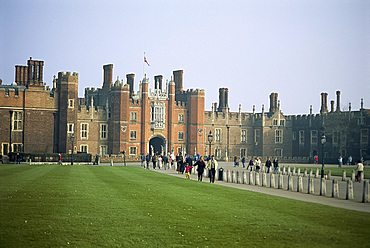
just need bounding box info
[0,58,370,163]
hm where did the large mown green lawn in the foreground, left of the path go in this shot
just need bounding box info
[0,165,370,247]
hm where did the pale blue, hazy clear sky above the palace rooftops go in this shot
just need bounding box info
[0,0,370,115]
